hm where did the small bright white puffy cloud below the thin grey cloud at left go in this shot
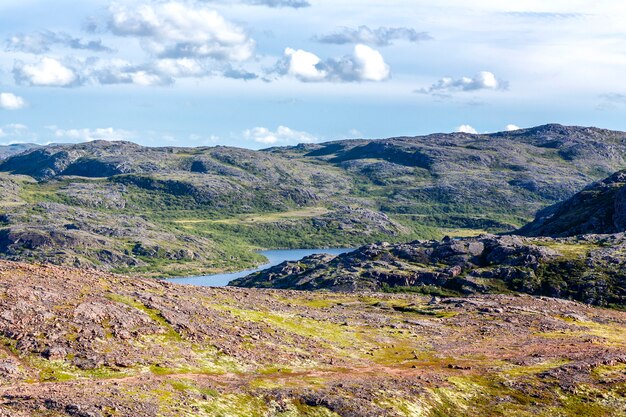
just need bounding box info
[13,57,80,87]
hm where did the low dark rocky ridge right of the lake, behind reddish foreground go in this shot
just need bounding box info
[230,233,626,308]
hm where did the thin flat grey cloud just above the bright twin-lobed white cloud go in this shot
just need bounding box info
[314,26,432,46]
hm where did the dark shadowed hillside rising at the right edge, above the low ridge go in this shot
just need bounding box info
[515,171,626,236]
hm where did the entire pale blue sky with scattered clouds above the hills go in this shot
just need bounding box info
[0,0,626,149]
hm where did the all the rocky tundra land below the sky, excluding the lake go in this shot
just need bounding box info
[0,125,626,417]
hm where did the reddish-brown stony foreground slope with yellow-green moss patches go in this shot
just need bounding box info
[0,262,626,417]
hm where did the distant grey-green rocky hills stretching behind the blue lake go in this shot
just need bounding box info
[0,125,626,276]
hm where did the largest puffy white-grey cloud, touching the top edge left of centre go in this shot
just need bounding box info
[108,2,255,62]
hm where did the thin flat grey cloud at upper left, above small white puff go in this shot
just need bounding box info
[6,30,112,54]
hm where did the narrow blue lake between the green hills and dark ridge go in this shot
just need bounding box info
[168,249,353,287]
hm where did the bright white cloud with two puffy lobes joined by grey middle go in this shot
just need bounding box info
[278,44,391,82]
